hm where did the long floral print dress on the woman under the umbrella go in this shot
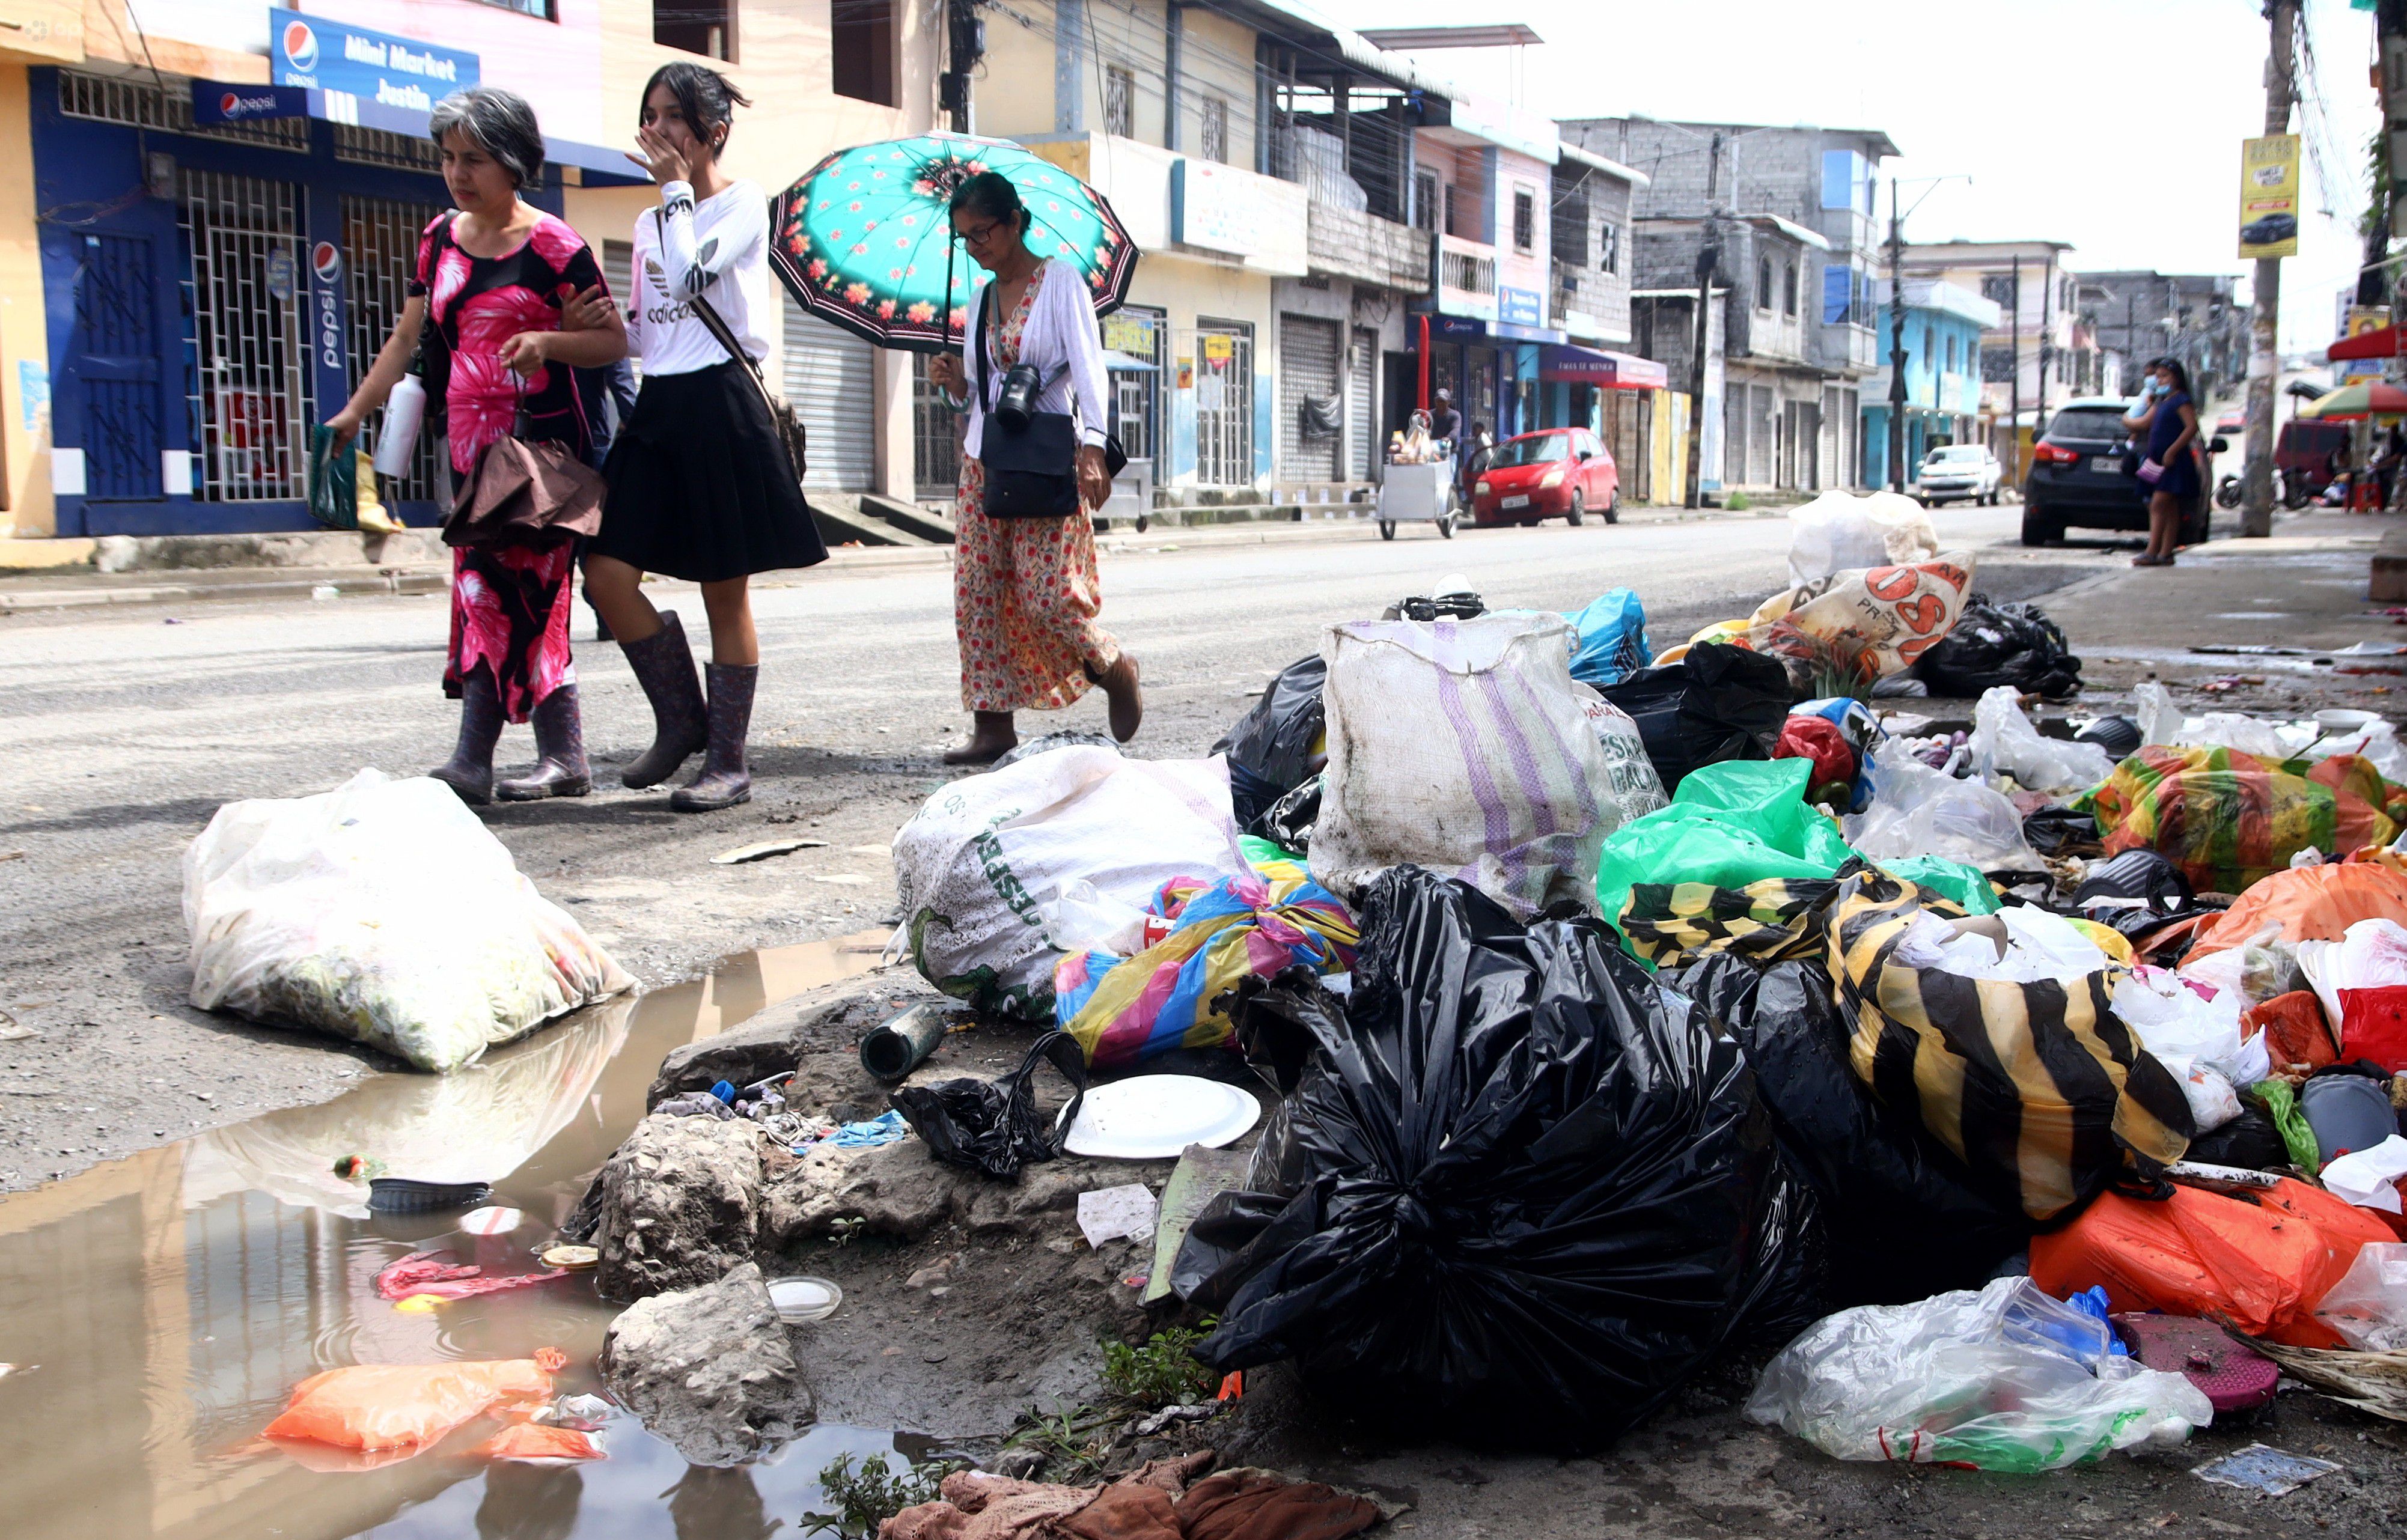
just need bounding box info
[953,265,1119,712]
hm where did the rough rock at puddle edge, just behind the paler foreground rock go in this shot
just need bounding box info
[594,1114,770,1300]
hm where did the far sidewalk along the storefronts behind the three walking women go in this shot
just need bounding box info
[0,495,1789,616]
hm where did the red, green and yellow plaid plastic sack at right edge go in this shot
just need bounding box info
[2072,743,2407,893]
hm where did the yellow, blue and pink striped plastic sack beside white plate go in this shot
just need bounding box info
[1054,862,1358,1068]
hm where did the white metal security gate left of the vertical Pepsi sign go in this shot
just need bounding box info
[180,166,316,503]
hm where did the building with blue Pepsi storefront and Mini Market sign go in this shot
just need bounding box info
[0,0,941,549]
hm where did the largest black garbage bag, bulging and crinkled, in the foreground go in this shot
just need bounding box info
[1172,866,1820,1453]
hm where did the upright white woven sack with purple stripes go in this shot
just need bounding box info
[1312,611,1622,919]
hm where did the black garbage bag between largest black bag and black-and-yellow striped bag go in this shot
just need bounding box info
[1658,953,2031,1309]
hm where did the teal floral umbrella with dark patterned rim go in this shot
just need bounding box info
[768,135,1136,352]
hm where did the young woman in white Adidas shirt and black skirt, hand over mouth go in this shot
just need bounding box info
[585,62,828,814]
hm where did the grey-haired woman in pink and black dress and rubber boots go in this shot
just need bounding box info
[328,87,626,804]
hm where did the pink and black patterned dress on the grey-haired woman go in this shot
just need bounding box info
[409,214,602,722]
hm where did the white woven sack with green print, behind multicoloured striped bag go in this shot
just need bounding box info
[895,746,1247,1020]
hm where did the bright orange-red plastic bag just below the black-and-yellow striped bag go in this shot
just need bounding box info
[2031,1176,2395,1348]
